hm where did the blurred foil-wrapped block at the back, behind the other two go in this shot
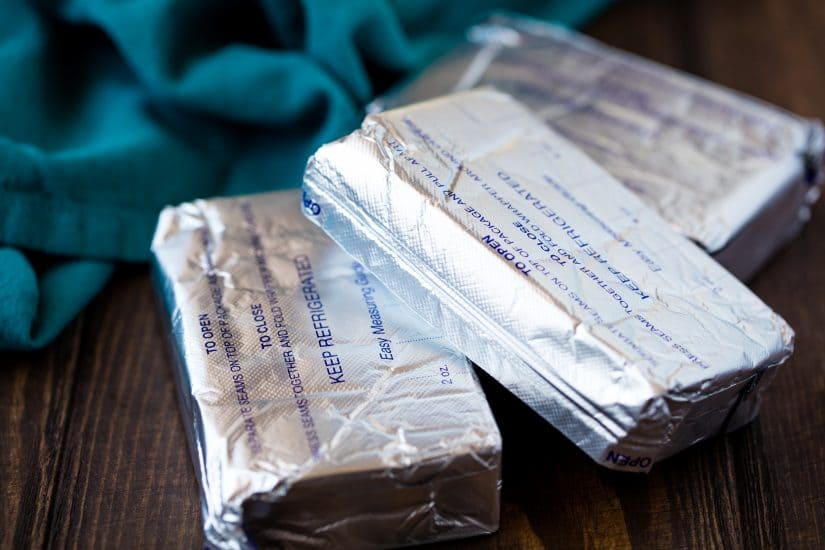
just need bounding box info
[371,15,825,279]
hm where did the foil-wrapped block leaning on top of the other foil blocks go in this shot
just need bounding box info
[304,89,793,471]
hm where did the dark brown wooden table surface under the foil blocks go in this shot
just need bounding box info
[0,0,825,548]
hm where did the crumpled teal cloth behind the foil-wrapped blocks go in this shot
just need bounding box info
[0,0,607,349]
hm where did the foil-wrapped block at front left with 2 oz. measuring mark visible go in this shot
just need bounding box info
[152,190,501,548]
